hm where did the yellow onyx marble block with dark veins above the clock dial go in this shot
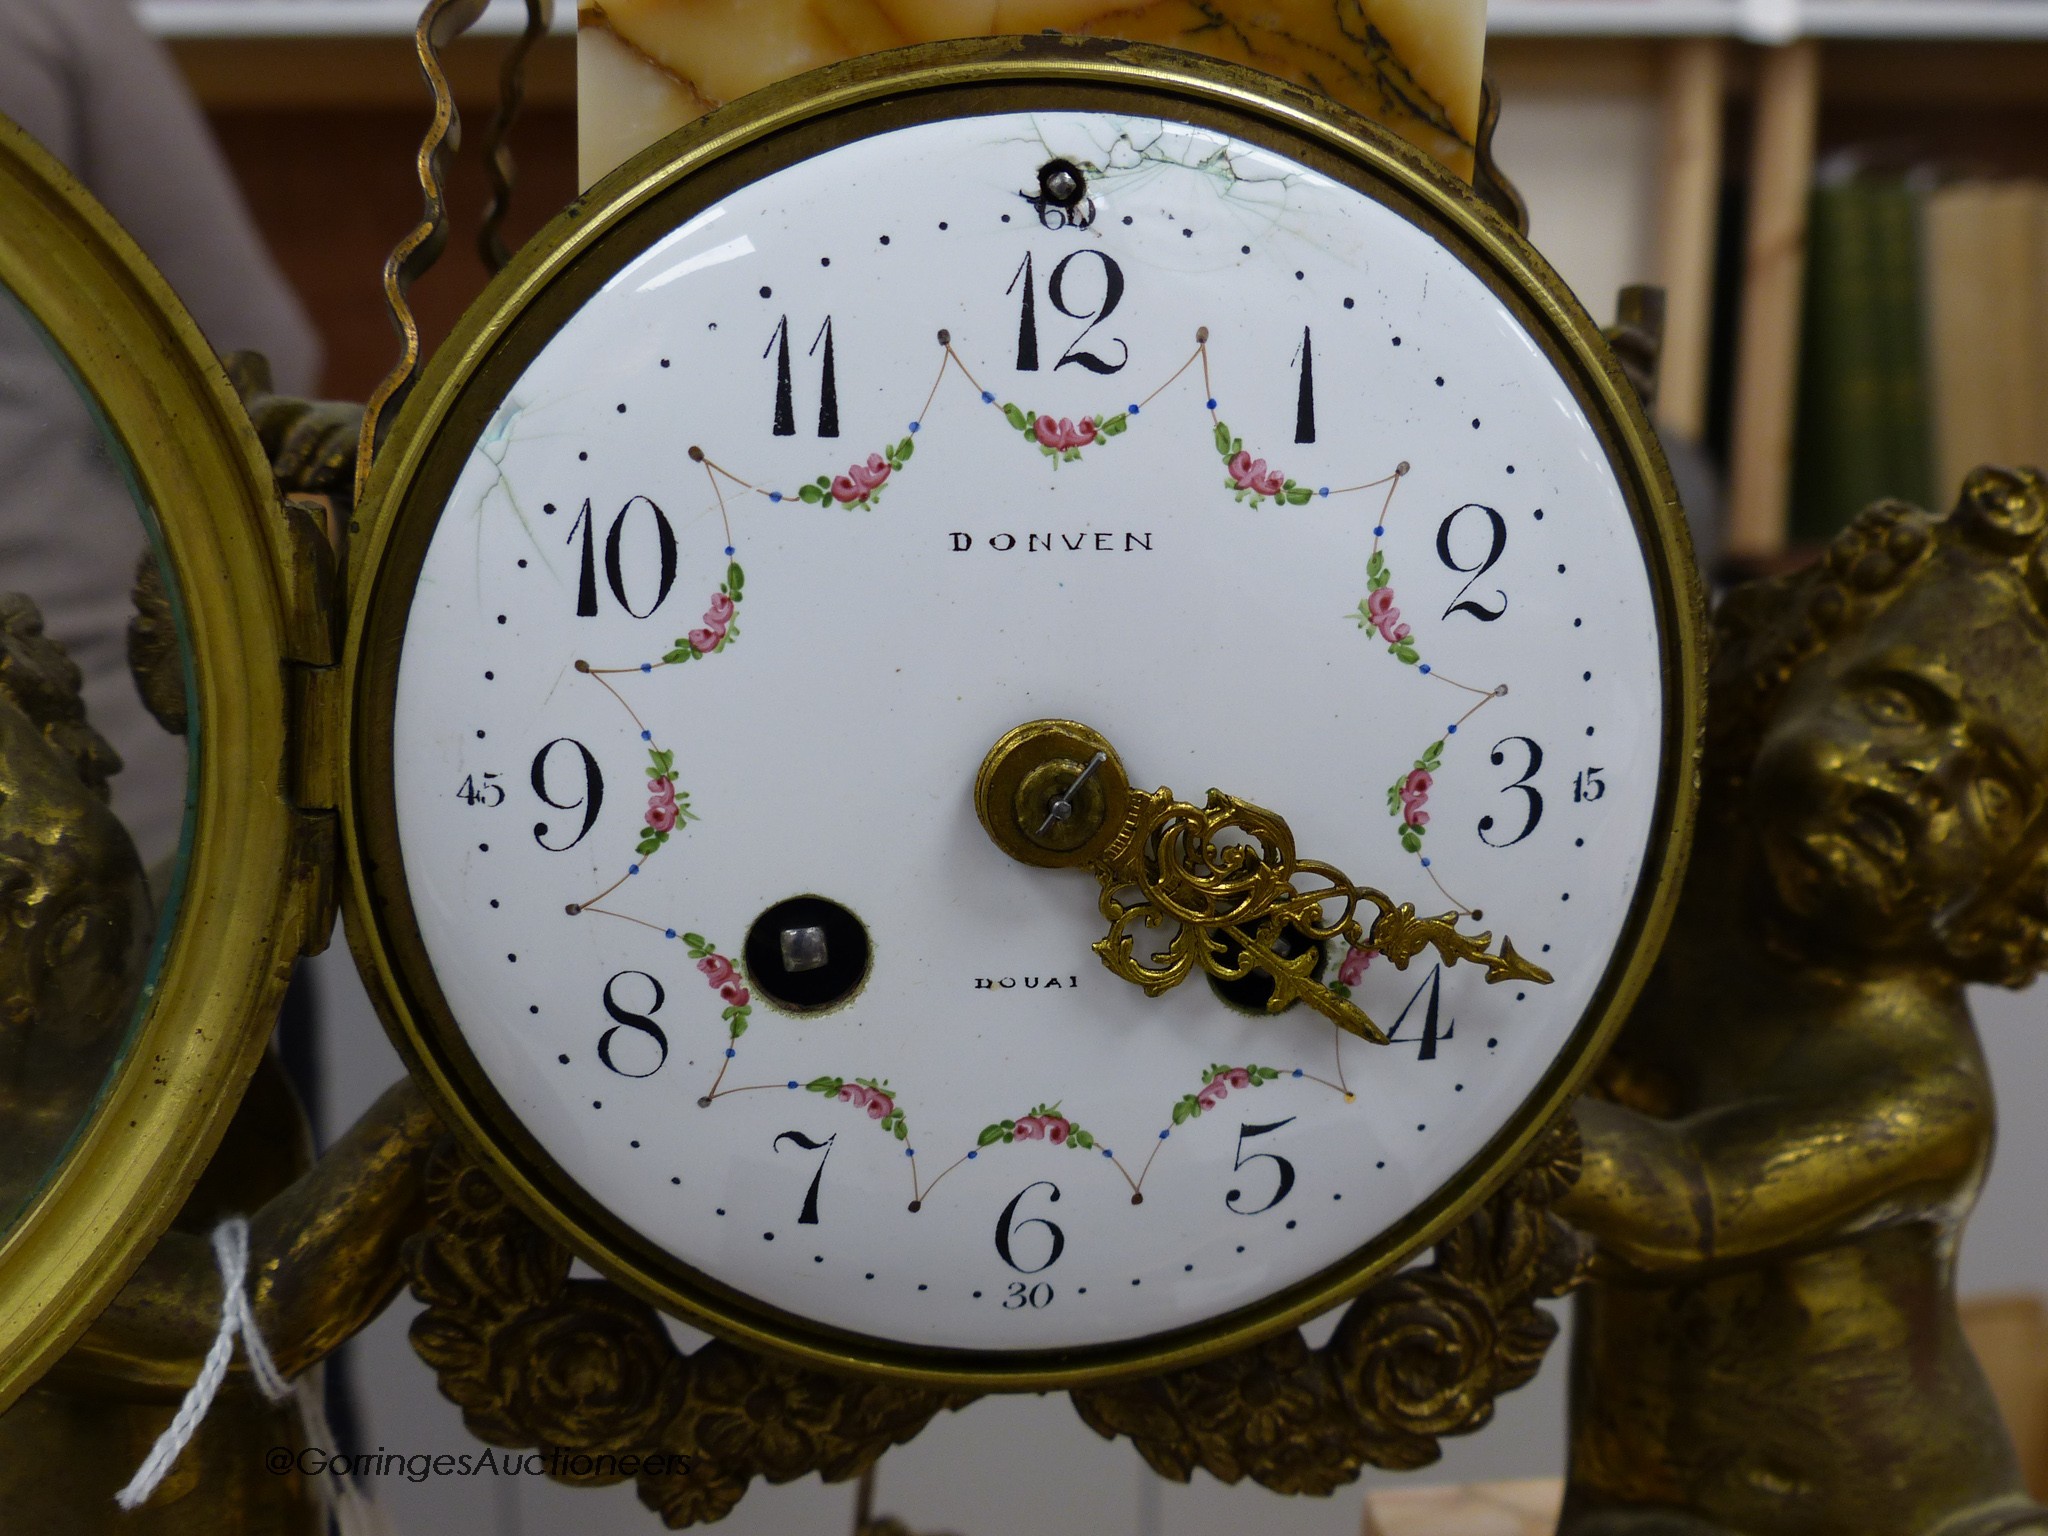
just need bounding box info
[578,0,1487,186]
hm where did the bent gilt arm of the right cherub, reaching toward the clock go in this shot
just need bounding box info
[1559,1065,1991,1274]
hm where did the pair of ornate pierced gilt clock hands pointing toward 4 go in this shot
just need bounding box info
[975,721,1550,1044]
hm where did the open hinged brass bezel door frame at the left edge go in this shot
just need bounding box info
[0,117,311,1409]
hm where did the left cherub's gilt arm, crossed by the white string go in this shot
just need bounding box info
[53,1079,440,1393]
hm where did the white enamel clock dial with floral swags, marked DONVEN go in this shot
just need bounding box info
[356,60,1677,1384]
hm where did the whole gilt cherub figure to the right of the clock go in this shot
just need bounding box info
[1559,469,2048,1536]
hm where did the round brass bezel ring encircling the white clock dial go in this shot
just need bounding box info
[342,37,1704,1391]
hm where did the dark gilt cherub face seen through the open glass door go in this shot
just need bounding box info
[0,705,150,1090]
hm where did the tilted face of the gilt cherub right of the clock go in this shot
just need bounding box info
[1747,555,2048,956]
